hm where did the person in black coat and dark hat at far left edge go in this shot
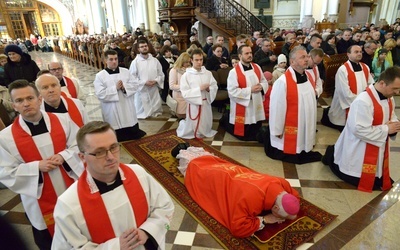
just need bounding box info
[4,44,40,86]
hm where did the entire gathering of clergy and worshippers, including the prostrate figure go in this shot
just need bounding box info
[0,18,400,249]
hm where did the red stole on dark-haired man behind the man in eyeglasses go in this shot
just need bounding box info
[11,113,74,236]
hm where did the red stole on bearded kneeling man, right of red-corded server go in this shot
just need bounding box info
[233,63,261,136]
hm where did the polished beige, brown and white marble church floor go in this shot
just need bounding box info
[0,52,400,250]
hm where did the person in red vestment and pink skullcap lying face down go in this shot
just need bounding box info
[172,144,300,238]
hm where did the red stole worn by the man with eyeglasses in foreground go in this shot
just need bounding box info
[78,164,149,244]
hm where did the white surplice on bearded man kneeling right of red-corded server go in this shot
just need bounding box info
[228,63,268,124]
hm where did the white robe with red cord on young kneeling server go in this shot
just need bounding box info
[176,66,218,139]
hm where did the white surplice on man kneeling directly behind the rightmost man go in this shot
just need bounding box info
[328,61,374,126]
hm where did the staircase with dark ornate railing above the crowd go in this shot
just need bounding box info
[195,0,269,37]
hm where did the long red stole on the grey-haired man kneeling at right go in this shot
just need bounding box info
[283,70,299,154]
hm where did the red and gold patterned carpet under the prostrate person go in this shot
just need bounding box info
[122,130,336,249]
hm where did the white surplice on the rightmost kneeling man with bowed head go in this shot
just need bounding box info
[335,85,398,178]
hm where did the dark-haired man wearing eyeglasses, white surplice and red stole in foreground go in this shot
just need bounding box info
[52,121,174,250]
